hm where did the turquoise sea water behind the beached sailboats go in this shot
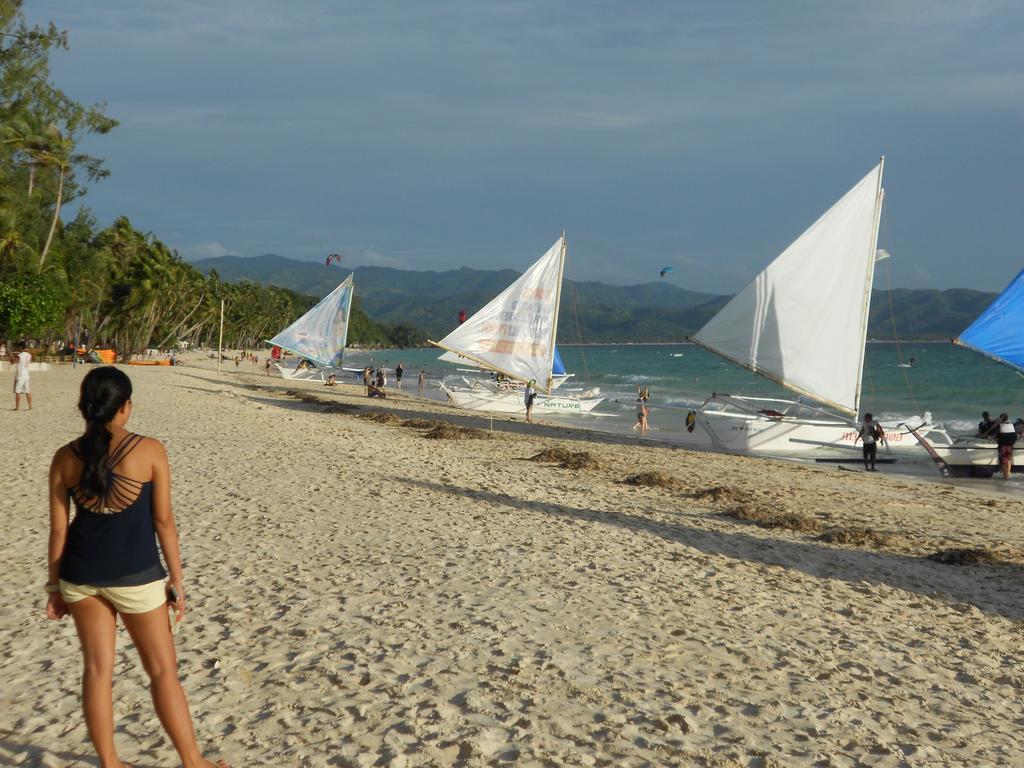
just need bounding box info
[345,342,1024,439]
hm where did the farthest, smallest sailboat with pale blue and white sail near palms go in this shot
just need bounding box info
[266,274,354,381]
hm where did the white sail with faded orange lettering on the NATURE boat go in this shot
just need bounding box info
[431,236,565,391]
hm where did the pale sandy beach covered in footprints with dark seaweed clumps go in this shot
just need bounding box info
[0,360,1024,768]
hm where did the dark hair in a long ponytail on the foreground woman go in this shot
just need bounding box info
[78,366,131,499]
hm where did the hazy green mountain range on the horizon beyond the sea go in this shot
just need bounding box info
[193,254,995,343]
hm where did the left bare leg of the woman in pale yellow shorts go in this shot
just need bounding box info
[68,597,124,768]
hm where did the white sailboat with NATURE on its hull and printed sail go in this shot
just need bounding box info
[429,232,603,414]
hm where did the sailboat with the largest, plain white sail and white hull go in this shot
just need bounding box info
[692,158,941,458]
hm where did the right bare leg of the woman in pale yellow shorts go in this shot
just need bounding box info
[121,605,220,768]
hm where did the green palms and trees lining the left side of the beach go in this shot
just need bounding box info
[0,0,419,354]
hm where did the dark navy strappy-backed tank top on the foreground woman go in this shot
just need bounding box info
[60,434,167,587]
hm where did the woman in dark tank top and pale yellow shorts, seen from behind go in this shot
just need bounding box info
[46,367,226,768]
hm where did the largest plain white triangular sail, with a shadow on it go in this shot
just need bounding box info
[693,162,883,414]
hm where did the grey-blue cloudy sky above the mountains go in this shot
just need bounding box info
[26,0,1024,293]
